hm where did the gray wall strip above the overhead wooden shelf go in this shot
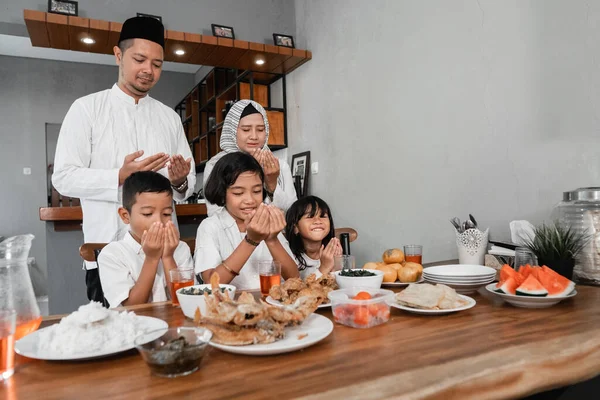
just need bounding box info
[0,0,295,43]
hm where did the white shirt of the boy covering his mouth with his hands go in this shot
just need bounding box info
[98,232,194,308]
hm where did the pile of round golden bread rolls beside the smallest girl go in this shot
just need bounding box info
[363,249,423,286]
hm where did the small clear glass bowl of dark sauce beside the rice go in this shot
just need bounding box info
[134,326,212,378]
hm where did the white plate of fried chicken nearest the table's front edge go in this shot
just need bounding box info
[194,274,333,355]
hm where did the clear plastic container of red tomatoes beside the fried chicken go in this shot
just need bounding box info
[327,287,394,328]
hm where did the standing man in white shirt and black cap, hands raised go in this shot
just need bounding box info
[52,17,196,301]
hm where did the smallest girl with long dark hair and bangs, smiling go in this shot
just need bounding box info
[285,196,342,279]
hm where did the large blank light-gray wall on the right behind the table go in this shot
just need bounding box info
[288,0,600,263]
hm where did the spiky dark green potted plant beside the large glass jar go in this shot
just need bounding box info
[525,222,591,279]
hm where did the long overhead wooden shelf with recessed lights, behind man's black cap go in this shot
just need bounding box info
[23,10,312,74]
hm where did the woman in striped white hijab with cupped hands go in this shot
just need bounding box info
[203,100,297,217]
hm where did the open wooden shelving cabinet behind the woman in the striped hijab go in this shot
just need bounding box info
[175,68,287,172]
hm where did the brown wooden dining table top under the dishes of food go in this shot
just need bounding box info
[0,278,600,400]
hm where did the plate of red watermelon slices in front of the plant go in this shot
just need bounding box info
[485,264,577,308]
